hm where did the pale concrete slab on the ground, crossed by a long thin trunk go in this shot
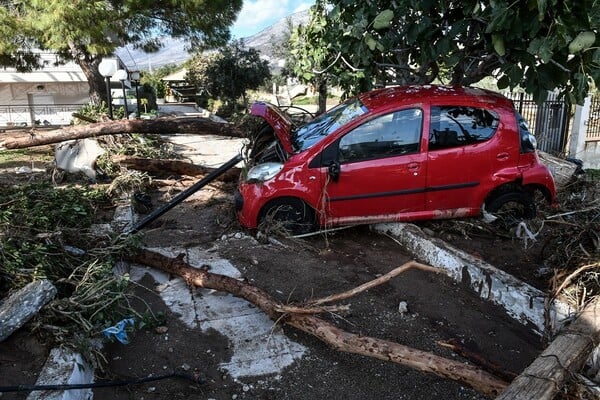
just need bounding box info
[130,248,307,379]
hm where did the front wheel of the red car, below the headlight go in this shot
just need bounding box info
[259,197,316,235]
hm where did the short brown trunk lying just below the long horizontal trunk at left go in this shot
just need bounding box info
[111,155,241,182]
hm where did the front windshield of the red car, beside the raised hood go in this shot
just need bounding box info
[292,98,368,151]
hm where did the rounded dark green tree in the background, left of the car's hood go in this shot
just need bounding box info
[187,41,271,108]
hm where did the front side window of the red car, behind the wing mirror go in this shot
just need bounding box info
[339,108,423,163]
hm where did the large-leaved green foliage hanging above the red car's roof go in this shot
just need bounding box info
[292,0,600,103]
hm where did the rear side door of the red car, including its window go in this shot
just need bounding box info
[426,105,501,215]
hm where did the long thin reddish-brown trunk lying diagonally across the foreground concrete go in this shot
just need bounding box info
[128,250,507,396]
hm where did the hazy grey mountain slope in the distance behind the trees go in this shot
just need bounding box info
[115,10,309,71]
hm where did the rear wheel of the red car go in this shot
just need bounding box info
[485,191,537,227]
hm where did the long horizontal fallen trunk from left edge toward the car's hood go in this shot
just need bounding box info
[0,117,245,149]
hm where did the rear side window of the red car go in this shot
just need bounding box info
[429,106,500,151]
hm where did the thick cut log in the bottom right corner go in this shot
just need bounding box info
[496,297,600,400]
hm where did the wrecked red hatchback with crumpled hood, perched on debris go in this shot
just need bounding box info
[236,85,555,233]
